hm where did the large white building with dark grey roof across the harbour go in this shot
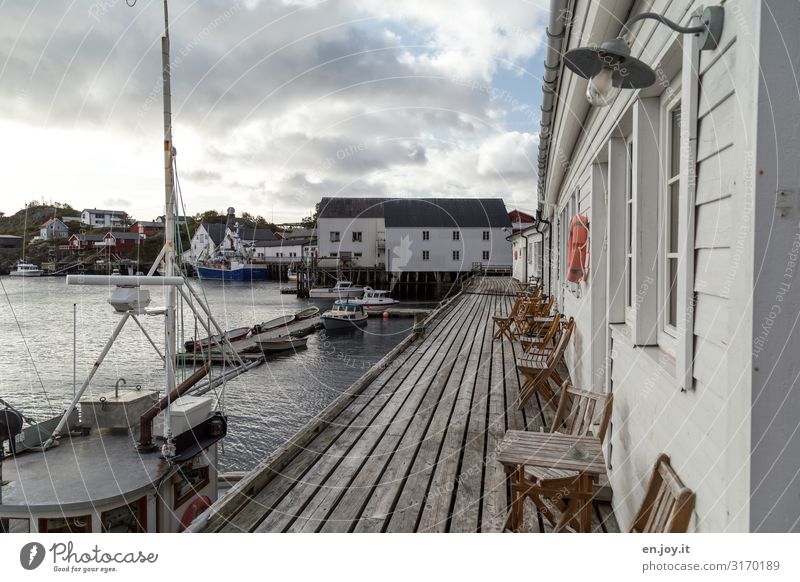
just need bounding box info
[317,198,512,273]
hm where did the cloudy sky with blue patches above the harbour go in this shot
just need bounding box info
[0,0,549,222]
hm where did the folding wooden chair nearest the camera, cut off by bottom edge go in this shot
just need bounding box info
[630,453,694,533]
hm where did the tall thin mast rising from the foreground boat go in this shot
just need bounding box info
[161,0,177,456]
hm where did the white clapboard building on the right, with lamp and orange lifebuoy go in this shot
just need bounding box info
[539,0,800,532]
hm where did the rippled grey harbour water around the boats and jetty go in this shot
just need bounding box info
[0,277,424,470]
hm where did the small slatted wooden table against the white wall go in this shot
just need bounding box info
[497,430,606,532]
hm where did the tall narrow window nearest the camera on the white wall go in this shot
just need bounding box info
[662,102,681,329]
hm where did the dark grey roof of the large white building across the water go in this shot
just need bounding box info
[319,198,511,228]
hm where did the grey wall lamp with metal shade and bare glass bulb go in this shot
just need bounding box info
[564,6,725,107]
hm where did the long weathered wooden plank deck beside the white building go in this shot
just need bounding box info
[192,277,616,532]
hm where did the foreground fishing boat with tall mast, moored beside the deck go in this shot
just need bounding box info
[0,0,250,536]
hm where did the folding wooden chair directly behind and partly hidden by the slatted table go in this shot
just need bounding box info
[522,382,614,531]
